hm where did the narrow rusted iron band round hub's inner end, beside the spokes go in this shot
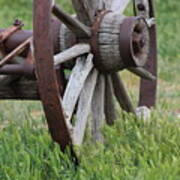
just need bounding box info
[90,10,112,72]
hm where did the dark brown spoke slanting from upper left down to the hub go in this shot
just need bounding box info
[52,5,91,37]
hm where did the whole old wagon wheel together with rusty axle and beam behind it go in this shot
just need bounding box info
[0,0,157,153]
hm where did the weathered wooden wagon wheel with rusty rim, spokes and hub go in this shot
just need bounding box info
[34,0,156,150]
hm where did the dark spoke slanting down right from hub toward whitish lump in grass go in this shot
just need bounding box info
[111,73,135,114]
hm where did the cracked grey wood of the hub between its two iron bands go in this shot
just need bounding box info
[97,13,124,72]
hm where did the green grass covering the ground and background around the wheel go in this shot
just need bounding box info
[0,0,180,180]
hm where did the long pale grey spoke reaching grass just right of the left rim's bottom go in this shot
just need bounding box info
[73,69,98,145]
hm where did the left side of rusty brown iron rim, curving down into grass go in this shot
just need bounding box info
[33,0,72,151]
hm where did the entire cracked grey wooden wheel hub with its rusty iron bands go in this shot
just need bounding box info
[91,11,149,73]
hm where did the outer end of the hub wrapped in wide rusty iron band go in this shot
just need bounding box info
[119,17,149,68]
